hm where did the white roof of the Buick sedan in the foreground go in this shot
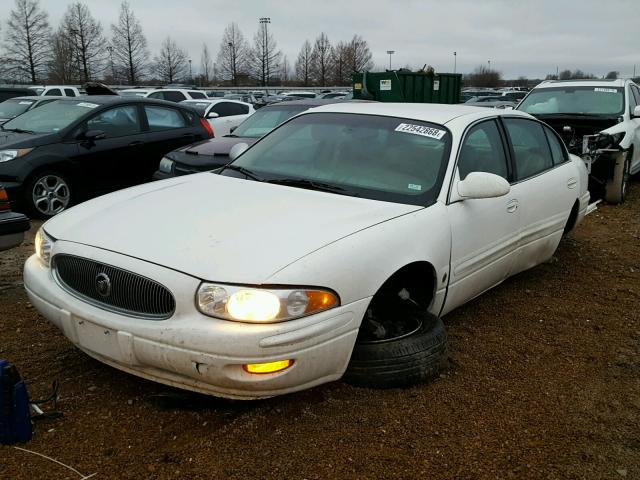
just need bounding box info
[304,102,530,125]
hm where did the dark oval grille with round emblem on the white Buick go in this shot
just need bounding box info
[53,254,176,320]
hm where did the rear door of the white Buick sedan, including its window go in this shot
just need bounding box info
[502,118,579,273]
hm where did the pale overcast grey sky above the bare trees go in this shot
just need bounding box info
[0,0,640,78]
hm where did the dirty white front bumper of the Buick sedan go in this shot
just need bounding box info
[24,241,370,399]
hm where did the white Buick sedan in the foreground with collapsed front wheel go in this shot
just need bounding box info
[25,103,589,399]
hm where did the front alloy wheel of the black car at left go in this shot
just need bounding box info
[25,171,71,218]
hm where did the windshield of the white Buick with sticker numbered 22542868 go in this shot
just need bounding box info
[224,113,451,206]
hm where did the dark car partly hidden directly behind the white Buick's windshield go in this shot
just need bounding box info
[153,99,337,180]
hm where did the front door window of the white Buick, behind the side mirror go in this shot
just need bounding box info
[458,120,509,180]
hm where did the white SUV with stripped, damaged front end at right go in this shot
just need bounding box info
[517,79,640,203]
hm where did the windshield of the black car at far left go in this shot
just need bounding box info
[2,100,95,133]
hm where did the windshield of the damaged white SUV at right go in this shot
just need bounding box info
[518,85,624,115]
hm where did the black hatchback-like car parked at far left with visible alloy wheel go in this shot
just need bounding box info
[0,95,213,218]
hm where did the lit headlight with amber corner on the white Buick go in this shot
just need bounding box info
[197,283,340,323]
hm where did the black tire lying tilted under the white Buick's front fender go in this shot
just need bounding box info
[343,307,447,388]
